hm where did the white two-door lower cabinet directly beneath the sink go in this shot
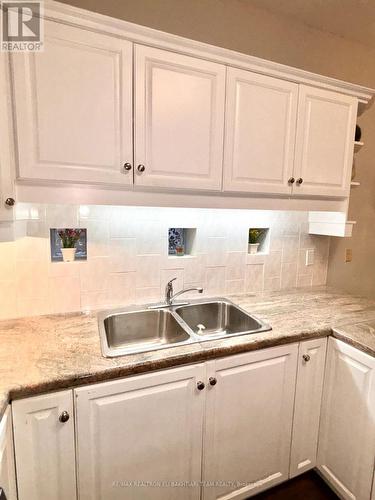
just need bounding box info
[75,344,298,500]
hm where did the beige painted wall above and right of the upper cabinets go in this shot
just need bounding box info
[55,0,375,297]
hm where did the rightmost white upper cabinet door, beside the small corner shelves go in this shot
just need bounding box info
[293,85,358,197]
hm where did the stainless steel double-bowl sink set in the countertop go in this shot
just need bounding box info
[98,298,271,357]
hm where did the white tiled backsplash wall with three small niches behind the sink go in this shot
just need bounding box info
[0,204,329,318]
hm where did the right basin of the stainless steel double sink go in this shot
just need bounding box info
[175,300,271,339]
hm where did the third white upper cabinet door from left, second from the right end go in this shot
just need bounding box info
[224,68,298,194]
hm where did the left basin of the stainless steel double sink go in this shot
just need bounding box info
[98,309,192,357]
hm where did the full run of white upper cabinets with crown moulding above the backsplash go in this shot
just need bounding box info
[6,5,375,207]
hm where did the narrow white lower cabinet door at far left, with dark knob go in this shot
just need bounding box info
[12,391,76,500]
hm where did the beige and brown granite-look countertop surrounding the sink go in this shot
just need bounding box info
[0,287,375,415]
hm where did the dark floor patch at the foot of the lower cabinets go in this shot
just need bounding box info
[253,472,338,500]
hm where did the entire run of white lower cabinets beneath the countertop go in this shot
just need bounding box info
[9,338,375,500]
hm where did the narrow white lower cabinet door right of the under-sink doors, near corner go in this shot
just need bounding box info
[290,338,327,477]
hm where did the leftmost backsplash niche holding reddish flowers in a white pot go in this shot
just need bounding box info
[50,228,87,262]
